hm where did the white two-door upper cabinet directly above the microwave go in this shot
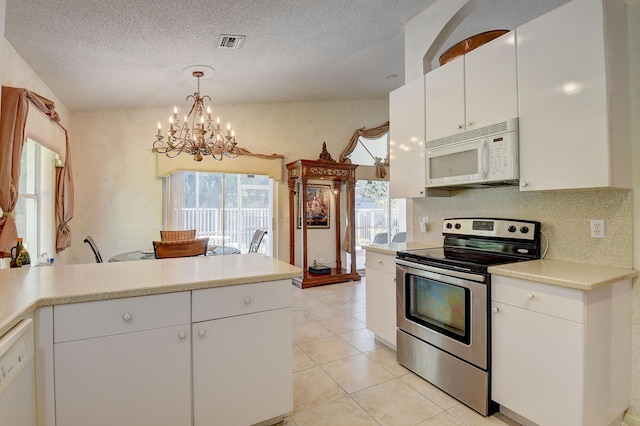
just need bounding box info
[425,31,518,141]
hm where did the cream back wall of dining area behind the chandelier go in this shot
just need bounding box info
[68,101,389,263]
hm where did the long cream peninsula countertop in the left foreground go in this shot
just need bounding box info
[0,254,302,336]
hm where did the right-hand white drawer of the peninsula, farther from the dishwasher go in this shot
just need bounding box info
[191,280,291,322]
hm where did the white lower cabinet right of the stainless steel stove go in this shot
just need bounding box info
[491,276,631,426]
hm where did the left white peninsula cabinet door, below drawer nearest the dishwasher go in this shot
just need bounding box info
[54,324,191,426]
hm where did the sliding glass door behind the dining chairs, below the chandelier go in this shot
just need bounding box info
[164,172,274,255]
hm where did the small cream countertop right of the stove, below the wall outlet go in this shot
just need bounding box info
[489,259,638,291]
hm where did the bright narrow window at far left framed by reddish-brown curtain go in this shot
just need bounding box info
[16,139,56,264]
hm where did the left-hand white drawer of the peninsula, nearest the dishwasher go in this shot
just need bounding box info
[53,291,191,343]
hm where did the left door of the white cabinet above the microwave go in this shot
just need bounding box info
[425,56,465,141]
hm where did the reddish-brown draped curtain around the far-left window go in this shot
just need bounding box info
[0,86,73,257]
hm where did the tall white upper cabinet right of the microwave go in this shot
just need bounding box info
[517,0,631,190]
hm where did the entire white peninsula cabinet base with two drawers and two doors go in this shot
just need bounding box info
[51,280,293,426]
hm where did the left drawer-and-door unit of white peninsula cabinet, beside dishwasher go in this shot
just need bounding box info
[54,293,191,426]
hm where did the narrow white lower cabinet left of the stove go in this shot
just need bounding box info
[365,251,397,350]
